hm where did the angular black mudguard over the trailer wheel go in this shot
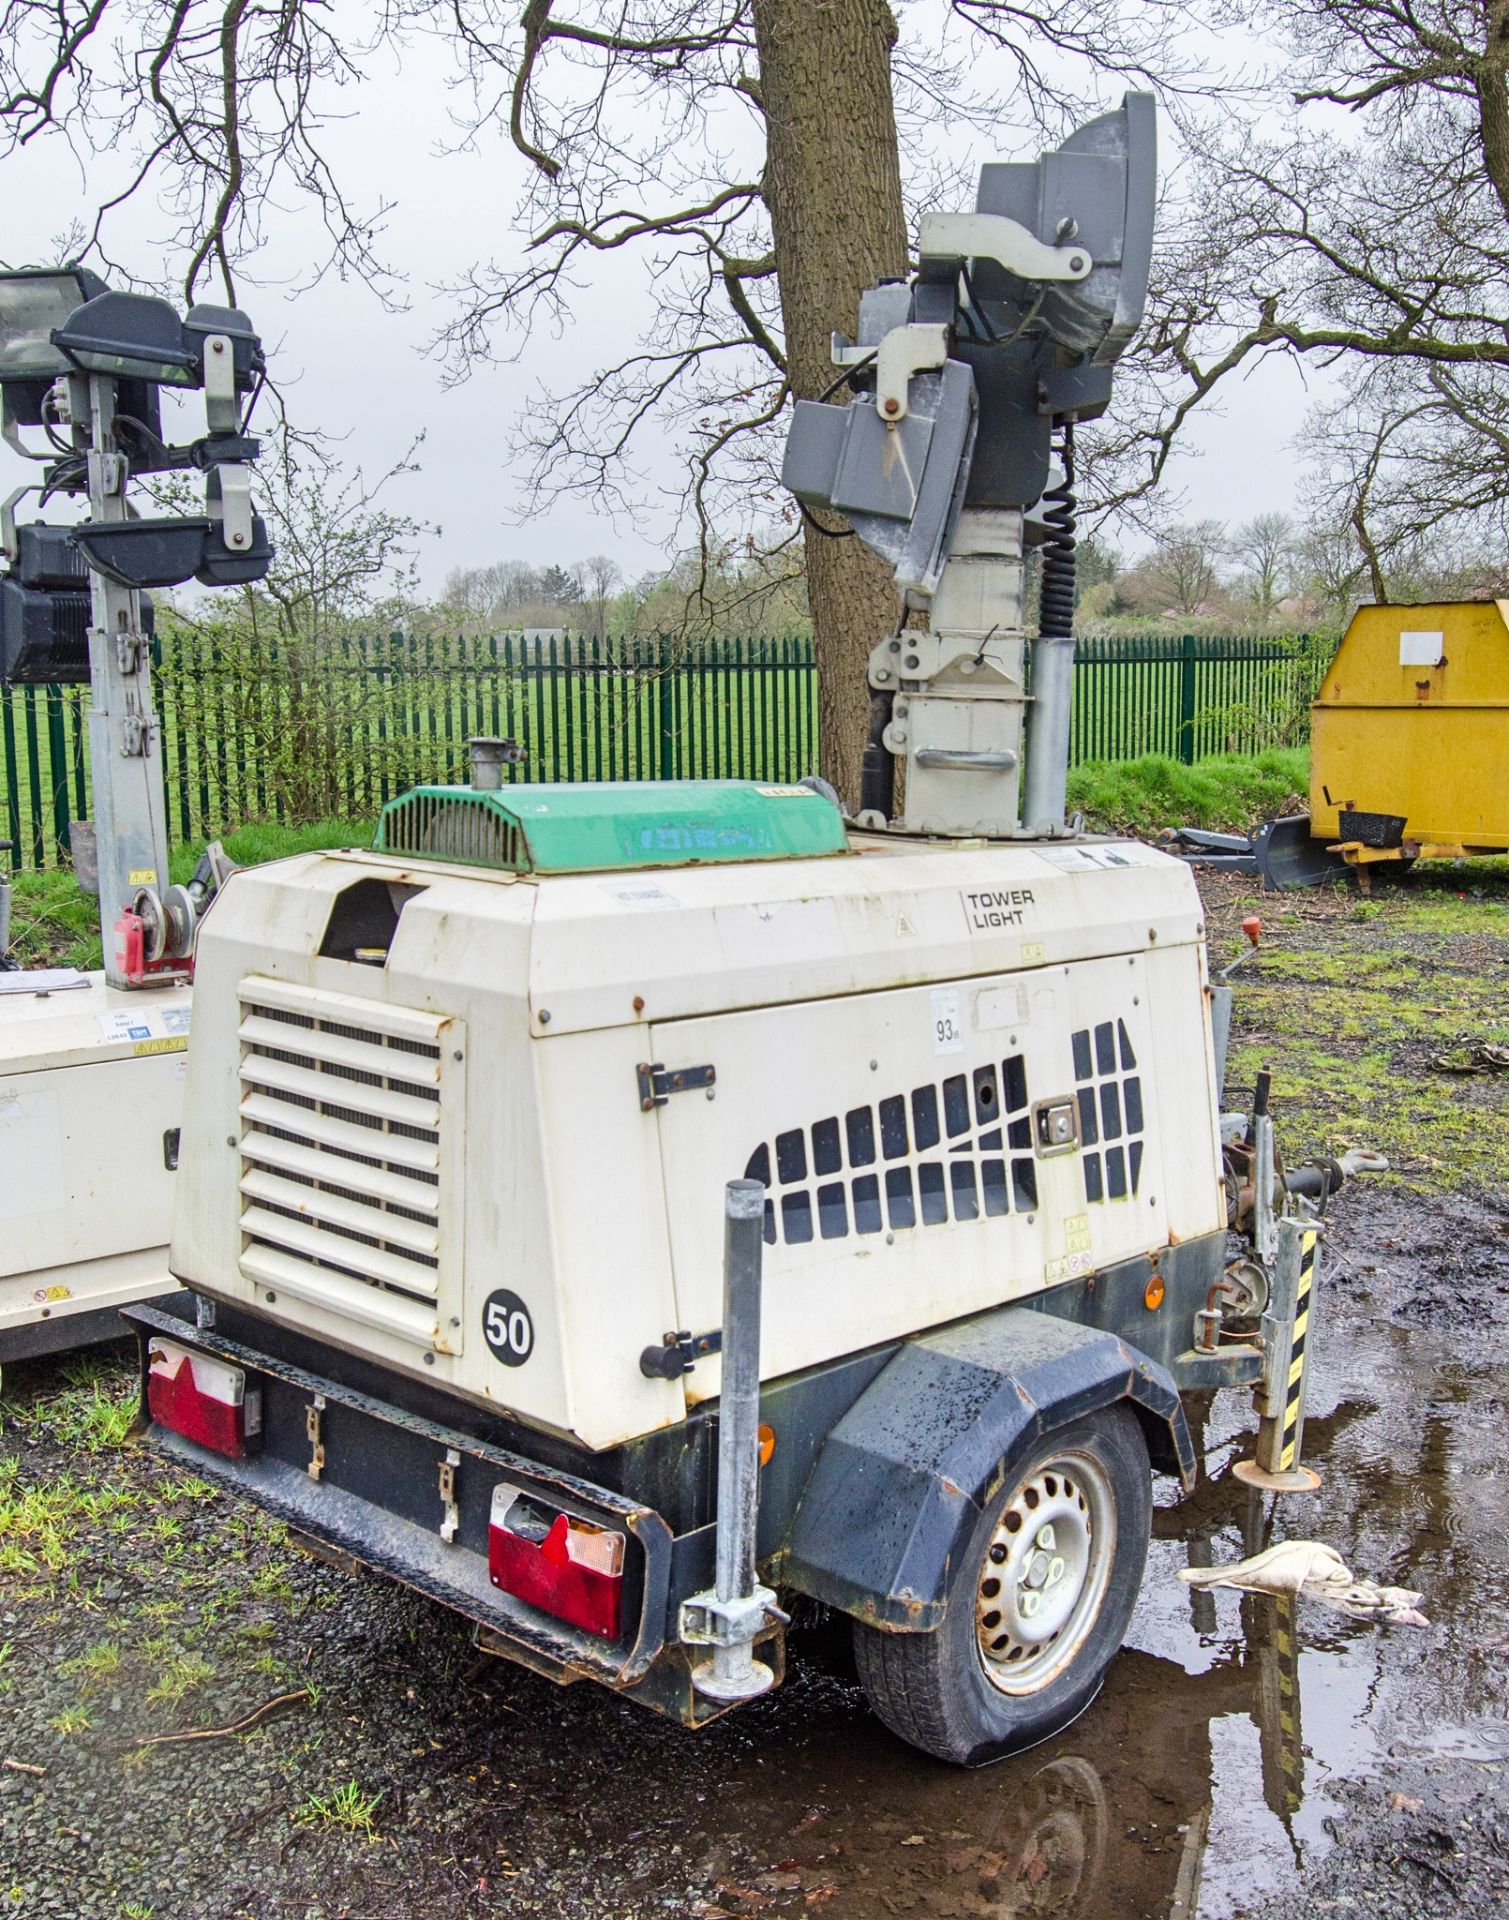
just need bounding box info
[779,1308,1194,1632]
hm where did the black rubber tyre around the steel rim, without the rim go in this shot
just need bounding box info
[854,1404,1152,1766]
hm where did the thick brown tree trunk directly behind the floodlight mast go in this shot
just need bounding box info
[753,0,906,806]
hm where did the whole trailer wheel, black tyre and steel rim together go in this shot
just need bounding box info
[854,1405,1152,1764]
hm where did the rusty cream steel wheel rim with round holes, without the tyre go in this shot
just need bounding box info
[975,1452,1115,1693]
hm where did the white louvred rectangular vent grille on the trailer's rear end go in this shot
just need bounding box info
[240,977,459,1346]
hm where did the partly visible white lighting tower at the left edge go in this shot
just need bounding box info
[0,267,271,1359]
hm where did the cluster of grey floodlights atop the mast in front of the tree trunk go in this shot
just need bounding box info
[781,94,1156,603]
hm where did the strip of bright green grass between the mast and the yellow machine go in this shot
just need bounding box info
[1069,747,1309,833]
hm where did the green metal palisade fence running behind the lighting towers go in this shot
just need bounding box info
[0,634,1330,868]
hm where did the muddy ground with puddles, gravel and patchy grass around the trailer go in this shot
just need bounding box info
[0,874,1509,1920]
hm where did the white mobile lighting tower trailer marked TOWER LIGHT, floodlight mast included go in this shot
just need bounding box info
[129,94,1366,1763]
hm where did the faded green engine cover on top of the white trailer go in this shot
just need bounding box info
[372,780,849,874]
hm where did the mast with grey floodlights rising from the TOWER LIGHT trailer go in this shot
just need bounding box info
[783,94,1156,839]
